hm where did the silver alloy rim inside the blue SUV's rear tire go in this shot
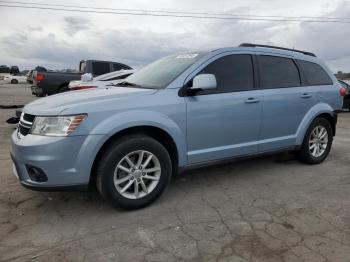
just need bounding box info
[309,126,328,157]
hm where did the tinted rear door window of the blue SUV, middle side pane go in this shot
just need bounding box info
[259,55,300,88]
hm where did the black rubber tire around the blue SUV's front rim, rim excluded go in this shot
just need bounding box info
[96,135,172,209]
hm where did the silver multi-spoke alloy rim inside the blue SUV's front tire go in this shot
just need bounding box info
[113,150,161,199]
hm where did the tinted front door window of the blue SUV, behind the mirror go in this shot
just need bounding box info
[199,55,254,93]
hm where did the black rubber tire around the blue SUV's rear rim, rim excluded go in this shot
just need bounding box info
[297,117,333,165]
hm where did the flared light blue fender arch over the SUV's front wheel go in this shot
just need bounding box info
[90,110,187,166]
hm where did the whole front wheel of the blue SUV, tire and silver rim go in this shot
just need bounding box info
[96,135,172,209]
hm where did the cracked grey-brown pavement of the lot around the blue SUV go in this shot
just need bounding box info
[0,84,350,262]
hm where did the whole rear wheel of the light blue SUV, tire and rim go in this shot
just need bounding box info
[298,118,333,164]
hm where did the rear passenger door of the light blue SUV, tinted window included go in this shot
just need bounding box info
[257,54,317,152]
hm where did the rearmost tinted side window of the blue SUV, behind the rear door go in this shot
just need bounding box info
[298,60,333,86]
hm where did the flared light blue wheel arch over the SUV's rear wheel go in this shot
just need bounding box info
[296,103,334,145]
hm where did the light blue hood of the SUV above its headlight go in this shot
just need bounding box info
[24,87,157,115]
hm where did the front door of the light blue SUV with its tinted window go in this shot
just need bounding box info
[185,54,262,164]
